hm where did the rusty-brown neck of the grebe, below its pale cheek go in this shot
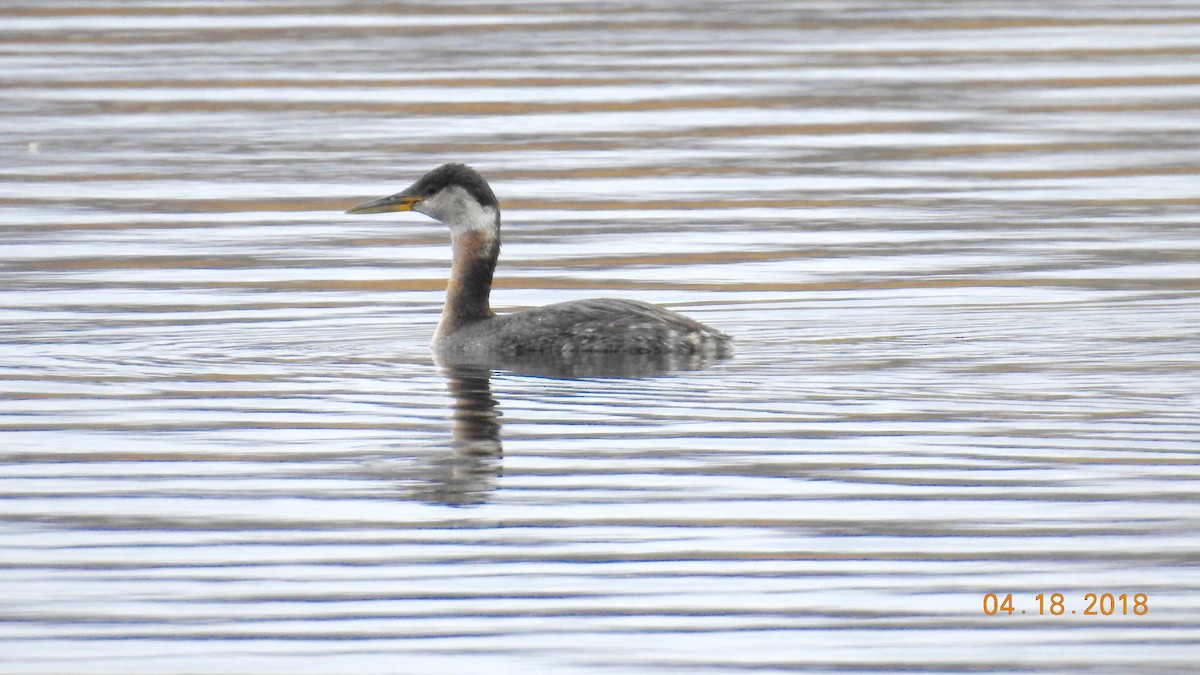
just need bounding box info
[433,224,500,342]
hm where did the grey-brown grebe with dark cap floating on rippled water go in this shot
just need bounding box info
[346,163,731,358]
